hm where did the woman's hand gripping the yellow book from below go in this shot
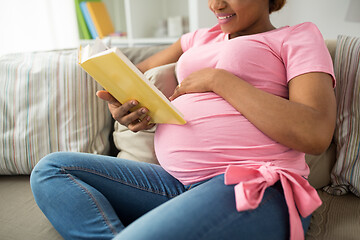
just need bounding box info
[96,91,154,132]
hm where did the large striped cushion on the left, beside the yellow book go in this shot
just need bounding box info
[0,49,111,175]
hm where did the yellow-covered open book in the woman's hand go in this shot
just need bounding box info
[79,39,186,124]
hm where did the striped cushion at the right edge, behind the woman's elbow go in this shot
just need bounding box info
[325,36,360,197]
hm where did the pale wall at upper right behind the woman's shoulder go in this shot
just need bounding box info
[271,0,360,39]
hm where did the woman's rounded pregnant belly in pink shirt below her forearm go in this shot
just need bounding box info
[155,93,288,181]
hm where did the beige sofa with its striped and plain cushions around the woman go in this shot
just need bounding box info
[0,36,360,240]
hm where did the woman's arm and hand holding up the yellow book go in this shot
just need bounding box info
[96,40,183,132]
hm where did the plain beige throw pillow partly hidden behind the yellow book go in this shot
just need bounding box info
[113,63,177,164]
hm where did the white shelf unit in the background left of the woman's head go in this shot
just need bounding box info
[90,0,216,46]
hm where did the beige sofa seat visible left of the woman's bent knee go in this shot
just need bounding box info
[0,176,63,240]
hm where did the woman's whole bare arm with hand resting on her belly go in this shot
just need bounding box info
[171,69,336,154]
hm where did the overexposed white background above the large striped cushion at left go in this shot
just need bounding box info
[0,0,79,55]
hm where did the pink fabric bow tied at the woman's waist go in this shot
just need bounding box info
[225,163,322,240]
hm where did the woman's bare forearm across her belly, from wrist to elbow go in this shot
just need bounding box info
[213,69,335,154]
